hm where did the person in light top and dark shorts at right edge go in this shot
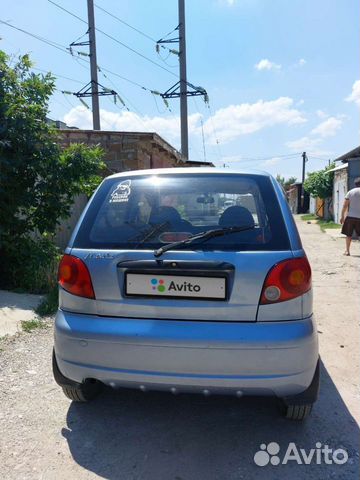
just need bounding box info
[340,177,360,256]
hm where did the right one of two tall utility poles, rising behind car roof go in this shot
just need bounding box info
[179,0,189,160]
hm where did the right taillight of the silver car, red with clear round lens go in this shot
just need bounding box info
[260,257,311,305]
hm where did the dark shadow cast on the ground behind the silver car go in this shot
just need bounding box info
[62,365,359,480]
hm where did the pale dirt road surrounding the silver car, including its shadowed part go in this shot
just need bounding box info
[0,221,360,480]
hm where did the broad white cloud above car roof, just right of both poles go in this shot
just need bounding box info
[204,97,306,143]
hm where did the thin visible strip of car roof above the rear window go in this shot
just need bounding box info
[107,167,271,178]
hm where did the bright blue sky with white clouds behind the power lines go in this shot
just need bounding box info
[0,0,360,179]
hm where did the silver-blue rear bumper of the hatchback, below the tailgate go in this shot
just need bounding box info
[55,310,318,397]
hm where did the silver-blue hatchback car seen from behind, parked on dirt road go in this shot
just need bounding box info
[53,168,319,420]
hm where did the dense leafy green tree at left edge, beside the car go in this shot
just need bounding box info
[0,50,104,292]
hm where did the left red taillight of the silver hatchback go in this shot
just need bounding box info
[58,255,95,298]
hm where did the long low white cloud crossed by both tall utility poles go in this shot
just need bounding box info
[64,106,201,145]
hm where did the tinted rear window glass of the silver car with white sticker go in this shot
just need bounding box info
[73,174,290,251]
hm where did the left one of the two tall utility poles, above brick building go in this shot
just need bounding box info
[87,0,100,130]
